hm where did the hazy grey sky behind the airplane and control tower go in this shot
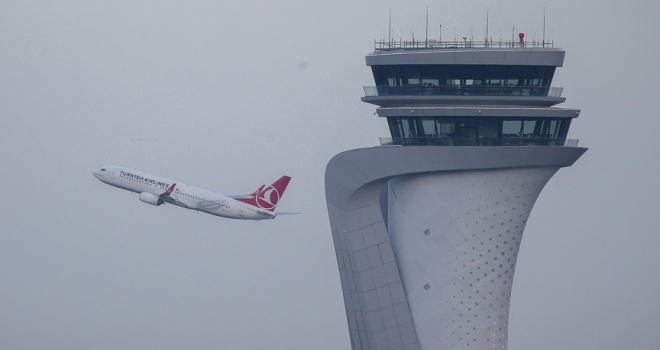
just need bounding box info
[0,0,660,350]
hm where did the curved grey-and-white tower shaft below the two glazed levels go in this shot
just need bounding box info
[326,146,586,350]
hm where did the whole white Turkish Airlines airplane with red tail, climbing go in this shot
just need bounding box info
[92,166,293,220]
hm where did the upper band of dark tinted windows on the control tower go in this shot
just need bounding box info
[371,65,555,95]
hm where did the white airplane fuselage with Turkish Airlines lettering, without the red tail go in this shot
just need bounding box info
[92,166,276,220]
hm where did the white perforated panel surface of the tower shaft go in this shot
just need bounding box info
[388,167,558,349]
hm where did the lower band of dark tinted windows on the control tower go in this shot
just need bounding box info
[387,117,571,146]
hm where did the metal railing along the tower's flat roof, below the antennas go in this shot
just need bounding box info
[374,38,554,51]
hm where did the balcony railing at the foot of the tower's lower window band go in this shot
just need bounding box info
[380,136,579,147]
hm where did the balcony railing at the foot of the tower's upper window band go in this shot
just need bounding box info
[364,85,564,98]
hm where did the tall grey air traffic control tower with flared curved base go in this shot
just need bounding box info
[325,36,586,350]
